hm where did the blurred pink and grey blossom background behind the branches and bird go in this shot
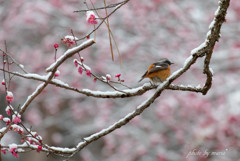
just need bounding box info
[0,0,240,161]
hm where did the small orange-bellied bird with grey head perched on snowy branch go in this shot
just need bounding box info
[138,58,174,83]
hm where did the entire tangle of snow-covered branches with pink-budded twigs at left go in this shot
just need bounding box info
[0,0,230,157]
